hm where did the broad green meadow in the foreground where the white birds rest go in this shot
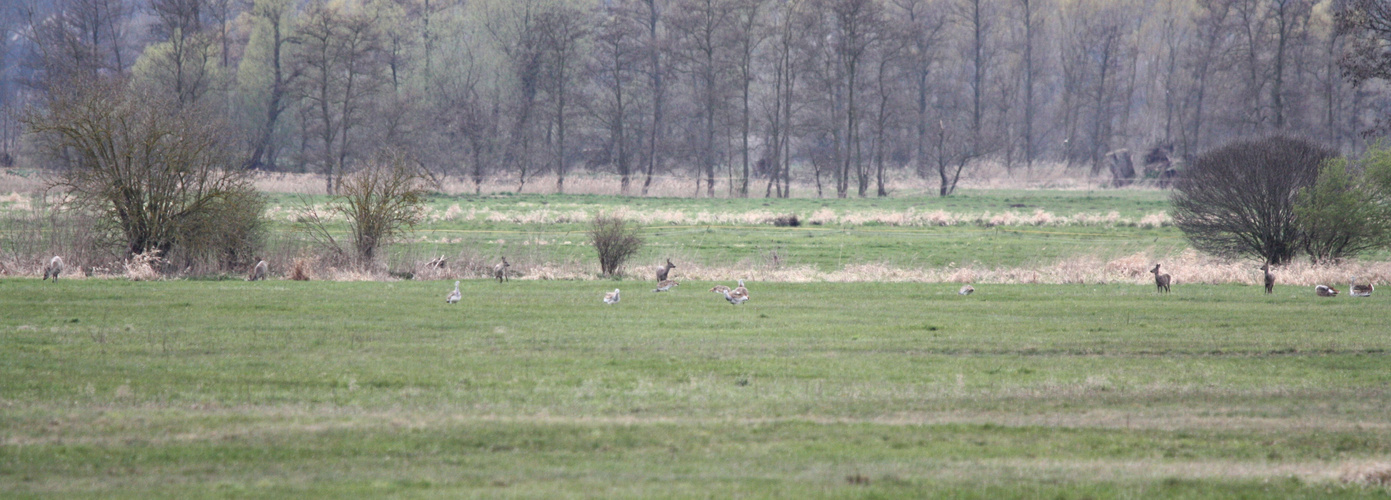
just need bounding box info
[0,279,1391,499]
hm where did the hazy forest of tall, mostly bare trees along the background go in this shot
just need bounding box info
[8,0,1391,196]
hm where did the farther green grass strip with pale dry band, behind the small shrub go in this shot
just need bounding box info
[258,189,1188,276]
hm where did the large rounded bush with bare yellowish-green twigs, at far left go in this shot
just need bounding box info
[25,79,262,261]
